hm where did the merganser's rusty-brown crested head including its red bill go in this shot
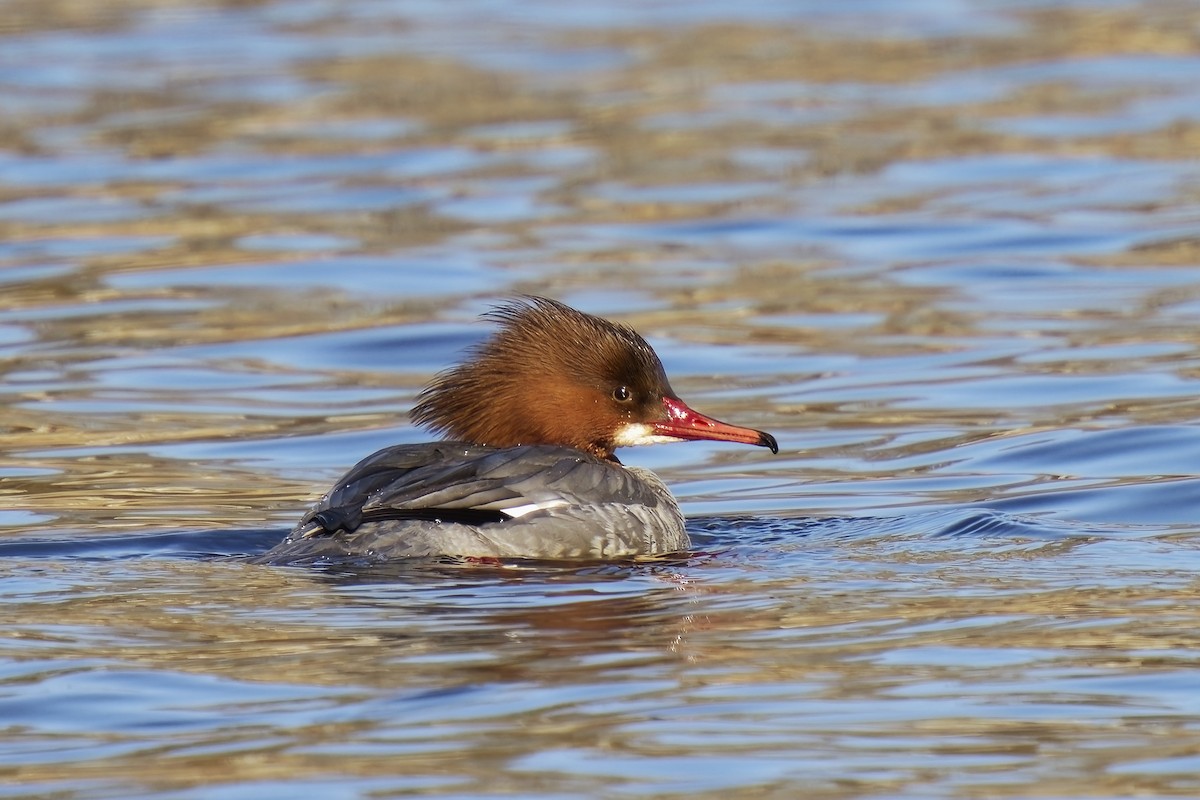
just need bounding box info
[412,296,778,461]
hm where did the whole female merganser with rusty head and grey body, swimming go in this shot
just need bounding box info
[259,297,779,564]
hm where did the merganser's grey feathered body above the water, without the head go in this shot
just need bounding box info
[259,441,689,564]
